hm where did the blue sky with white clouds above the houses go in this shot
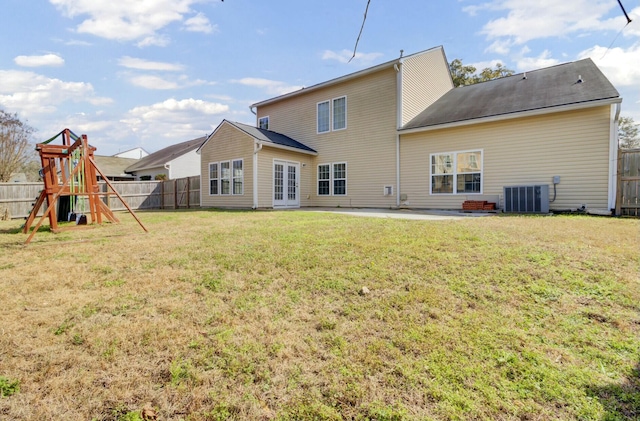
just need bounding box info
[0,0,640,155]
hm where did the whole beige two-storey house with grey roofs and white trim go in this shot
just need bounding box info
[198,47,621,210]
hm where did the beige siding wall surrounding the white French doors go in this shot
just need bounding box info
[258,145,313,208]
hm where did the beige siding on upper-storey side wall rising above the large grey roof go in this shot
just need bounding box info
[401,48,453,126]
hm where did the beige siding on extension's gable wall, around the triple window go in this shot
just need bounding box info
[200,120,254,208]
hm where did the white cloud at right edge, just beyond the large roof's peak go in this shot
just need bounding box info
[578,44,640,87]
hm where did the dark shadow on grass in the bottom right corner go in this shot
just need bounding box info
[588,363,640,421]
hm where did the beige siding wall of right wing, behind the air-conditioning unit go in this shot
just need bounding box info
[400,106,610,210]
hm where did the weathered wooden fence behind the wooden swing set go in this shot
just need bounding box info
[0,176,200,218]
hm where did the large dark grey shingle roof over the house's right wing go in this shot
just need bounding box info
[402,58,620,130]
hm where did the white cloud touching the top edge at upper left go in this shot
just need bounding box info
[49,0,210,46]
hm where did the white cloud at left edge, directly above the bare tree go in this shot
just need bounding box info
[0,70,113,115]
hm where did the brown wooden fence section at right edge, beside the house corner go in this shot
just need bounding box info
[616,149,640,216]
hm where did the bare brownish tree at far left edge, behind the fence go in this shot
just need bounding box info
[0,110,35,182]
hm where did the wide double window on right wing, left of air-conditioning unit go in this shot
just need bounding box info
[431,151,482,194]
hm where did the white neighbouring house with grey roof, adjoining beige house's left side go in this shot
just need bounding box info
[126,136,205,180]
